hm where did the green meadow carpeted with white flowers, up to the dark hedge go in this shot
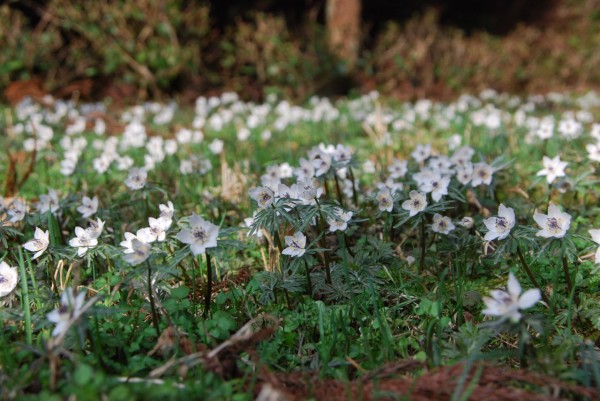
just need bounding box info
[0,90,600,400]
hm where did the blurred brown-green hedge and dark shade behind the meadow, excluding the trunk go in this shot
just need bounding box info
[0,0,600,100]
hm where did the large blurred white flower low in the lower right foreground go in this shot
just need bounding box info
[482,273,541,323]
